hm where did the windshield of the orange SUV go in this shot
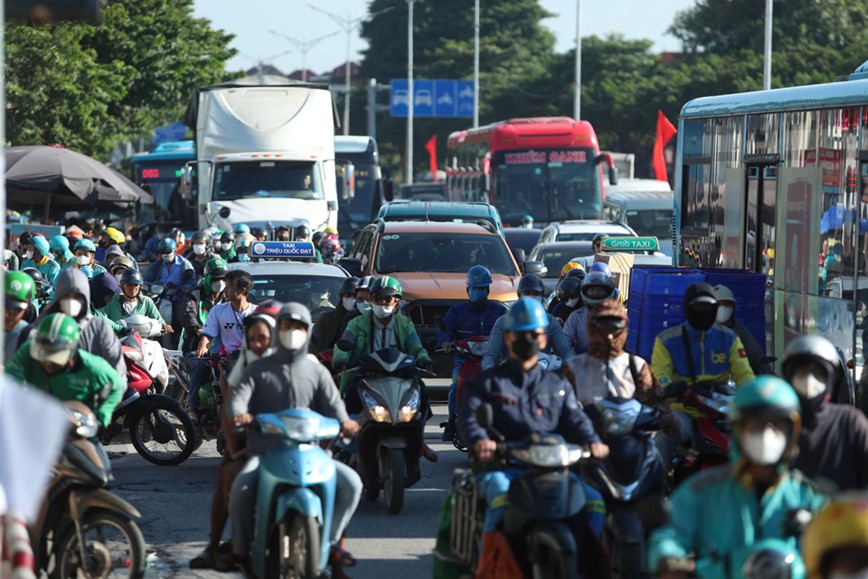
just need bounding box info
[375,232,518,276]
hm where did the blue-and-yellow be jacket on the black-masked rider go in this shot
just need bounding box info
[651,322,754,388]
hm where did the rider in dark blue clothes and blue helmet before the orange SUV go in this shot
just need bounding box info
[437,265,507,442]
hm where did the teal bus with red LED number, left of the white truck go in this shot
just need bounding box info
[130,141,197,229]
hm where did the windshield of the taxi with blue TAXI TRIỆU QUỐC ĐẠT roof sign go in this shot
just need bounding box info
[250,275,344,322]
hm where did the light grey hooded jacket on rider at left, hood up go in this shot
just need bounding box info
[28,267,127,378]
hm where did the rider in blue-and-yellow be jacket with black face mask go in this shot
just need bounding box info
[651,283,754,469]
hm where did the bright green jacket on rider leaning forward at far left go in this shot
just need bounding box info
[6,342,126,427]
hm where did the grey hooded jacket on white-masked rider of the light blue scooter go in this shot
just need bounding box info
[229,302,349,454]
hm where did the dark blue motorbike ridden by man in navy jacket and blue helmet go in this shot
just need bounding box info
[435,404,591,579]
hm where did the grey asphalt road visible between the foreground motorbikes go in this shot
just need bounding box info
[109,405,465,579]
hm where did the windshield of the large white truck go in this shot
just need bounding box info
[214,161,325,201]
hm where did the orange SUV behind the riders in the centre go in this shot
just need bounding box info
[341,219,521,369]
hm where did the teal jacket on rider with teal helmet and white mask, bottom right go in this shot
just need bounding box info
[648,464,826,579]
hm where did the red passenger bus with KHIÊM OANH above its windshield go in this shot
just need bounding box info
[446,117,617,225]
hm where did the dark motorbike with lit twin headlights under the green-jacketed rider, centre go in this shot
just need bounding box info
[352,348,426,514]
